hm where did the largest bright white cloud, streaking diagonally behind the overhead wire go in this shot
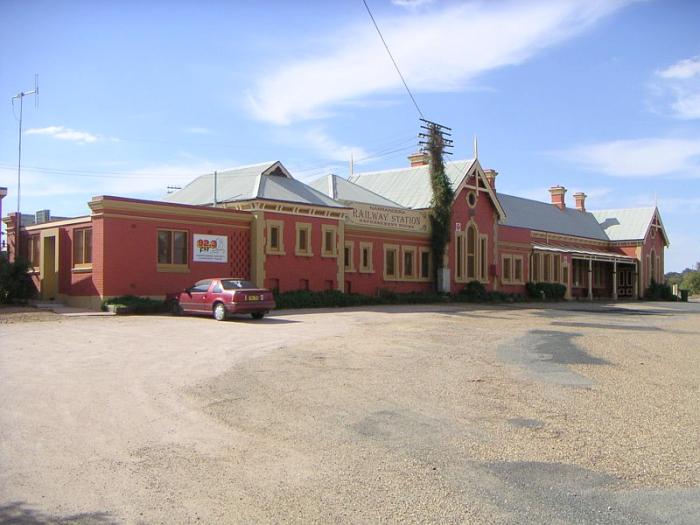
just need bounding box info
[249,0,630,124]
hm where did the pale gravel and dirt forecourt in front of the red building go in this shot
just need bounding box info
[0,303,700,524]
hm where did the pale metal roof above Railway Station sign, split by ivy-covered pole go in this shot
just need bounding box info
[348,159,474,209]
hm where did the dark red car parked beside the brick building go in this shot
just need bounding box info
[173,277,275,321]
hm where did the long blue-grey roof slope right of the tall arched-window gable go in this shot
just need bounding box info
[498,193,608,241]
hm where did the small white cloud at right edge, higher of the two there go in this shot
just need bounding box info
[652,56,700,120]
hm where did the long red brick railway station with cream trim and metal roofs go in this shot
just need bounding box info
[4,154,668,308]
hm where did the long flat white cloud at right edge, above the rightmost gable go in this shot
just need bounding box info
[556,138,700,178]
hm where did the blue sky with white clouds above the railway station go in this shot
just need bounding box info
[0,0,700,270]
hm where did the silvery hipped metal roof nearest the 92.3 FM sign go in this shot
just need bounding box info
[163,161,343,208]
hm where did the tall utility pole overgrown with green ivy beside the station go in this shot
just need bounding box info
[427,124,454,288]
